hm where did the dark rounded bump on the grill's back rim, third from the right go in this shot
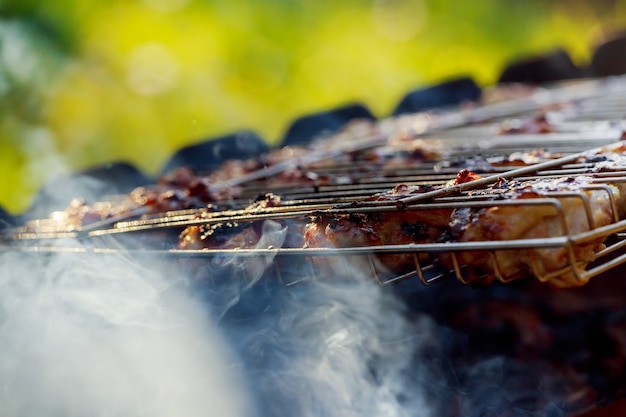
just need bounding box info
[393,77,481,116]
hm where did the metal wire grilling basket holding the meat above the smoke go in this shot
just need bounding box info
[2,78,626,284]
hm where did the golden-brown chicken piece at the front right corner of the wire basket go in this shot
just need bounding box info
[439,176,622,287]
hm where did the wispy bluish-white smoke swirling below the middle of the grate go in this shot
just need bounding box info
[228,278,434,417]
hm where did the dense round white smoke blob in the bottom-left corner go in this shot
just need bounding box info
[0,244,248,417]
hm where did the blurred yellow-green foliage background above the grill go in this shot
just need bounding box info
[0,0,626,212]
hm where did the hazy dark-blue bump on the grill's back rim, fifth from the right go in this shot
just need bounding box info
[161,130,269,175]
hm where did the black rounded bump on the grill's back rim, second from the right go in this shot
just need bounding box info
[498,49,585,84]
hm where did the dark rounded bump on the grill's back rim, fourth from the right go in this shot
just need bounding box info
[281,104,375,146]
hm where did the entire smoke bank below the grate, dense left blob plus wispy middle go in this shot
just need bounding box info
[0,236,438,417]
